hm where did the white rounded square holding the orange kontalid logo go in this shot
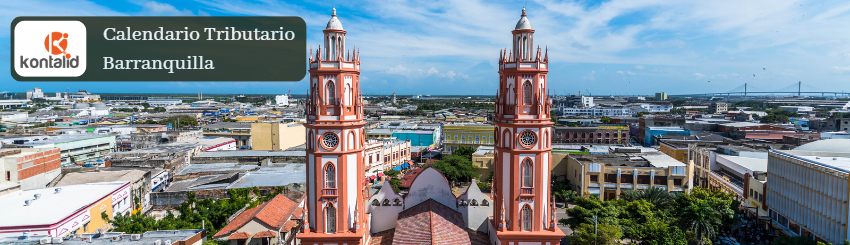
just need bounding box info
[12,20,86,77]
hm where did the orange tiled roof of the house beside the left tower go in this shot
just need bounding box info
[213,194,306,237]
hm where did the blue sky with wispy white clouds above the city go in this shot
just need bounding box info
[0,0,850,95]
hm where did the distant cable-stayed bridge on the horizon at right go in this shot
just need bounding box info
[667,82,850,97]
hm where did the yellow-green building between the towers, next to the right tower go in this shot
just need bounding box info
[442,124,494,154]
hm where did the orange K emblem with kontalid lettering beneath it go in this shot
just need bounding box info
[21,31,80,68]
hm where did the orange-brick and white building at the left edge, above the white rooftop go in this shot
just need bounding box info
[0,148,62,195]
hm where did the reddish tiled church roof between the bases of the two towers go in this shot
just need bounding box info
[392,199,471,244]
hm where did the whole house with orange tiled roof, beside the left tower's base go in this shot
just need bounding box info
[213,194,306,245]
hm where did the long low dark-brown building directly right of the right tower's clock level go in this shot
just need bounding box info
[552,126,629,145]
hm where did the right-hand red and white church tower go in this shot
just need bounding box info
[492,8,564,244]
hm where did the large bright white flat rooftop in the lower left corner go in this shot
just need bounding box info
[0,182,127,227]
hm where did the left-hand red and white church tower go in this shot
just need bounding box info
[298,8,369,245]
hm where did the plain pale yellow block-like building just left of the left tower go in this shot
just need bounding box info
[251,123,307,151]
